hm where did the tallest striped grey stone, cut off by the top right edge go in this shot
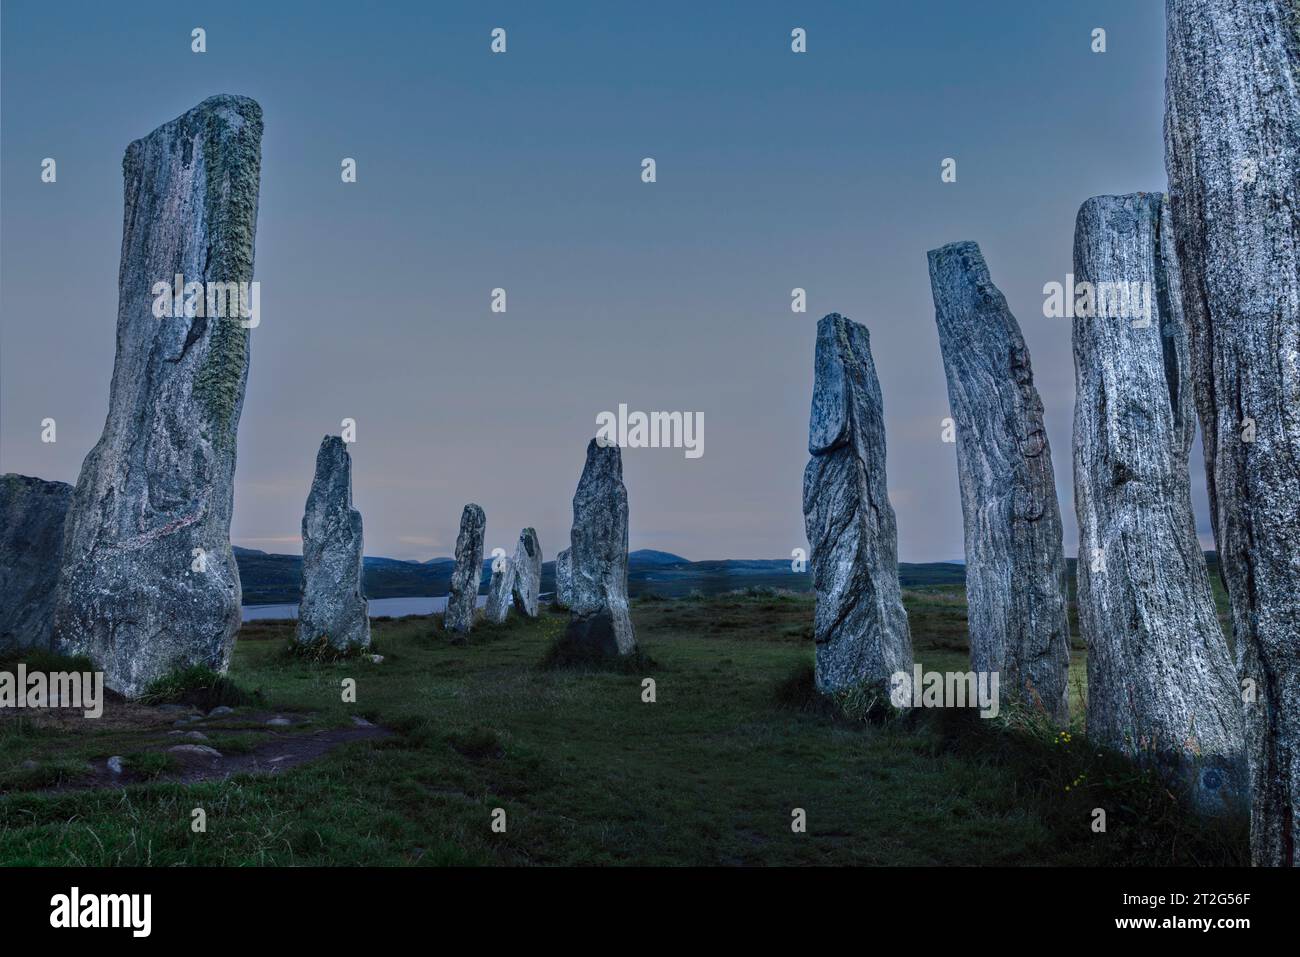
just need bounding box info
[1165,0,1300,866]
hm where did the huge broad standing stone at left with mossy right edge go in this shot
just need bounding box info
[55,96,261,696]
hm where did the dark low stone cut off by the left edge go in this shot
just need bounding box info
[0,473,73,651]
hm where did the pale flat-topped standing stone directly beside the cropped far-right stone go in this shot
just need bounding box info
[1074,192,1247,813]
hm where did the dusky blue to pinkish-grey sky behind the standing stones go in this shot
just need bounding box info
[0,0,1210,562]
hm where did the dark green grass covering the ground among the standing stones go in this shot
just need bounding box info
[0,586,1247,865]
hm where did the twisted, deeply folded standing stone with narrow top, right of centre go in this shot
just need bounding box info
[803,313,913,700]
